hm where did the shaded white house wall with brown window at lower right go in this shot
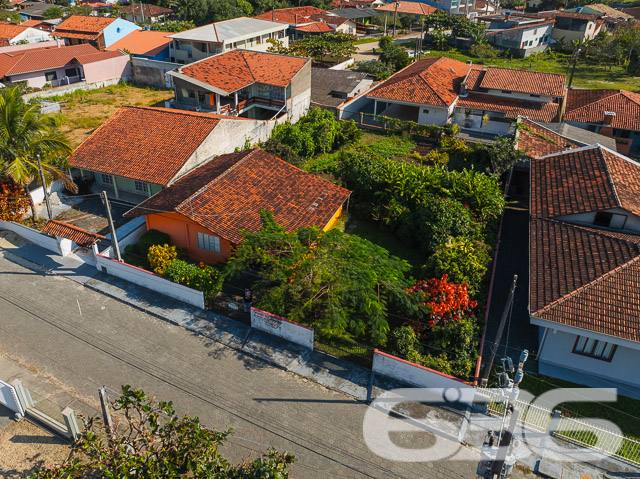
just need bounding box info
[540,329,640,398]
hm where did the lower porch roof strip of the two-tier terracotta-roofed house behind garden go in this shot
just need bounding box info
[456,92,559,122]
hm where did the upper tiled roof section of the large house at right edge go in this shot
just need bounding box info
[531,145,640,218]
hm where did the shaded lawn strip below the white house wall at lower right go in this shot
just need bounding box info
[522,374,640,440]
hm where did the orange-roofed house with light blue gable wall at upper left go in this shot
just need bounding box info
[53,15,141,50]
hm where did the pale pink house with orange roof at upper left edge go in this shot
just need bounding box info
[0,44,131,88]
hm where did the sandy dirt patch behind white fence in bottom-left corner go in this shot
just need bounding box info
[0,420,70,478]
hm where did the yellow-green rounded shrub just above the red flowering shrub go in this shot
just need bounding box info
[425,237,491,295]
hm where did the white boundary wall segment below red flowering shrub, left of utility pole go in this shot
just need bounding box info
[371,349,475,406]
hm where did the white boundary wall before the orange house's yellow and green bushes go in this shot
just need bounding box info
[96,254,204,309]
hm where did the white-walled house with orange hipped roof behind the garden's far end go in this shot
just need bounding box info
[365,57,471,125]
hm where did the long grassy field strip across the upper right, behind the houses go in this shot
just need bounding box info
[428,48,640,92]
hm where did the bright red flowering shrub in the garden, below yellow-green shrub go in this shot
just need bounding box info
[408,274,477,327]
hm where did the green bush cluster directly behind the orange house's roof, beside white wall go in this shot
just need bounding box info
[264,108,362,160]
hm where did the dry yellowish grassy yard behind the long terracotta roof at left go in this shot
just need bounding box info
[55,83,173,148]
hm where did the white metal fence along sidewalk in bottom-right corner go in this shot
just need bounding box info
[476,387,640,466]
